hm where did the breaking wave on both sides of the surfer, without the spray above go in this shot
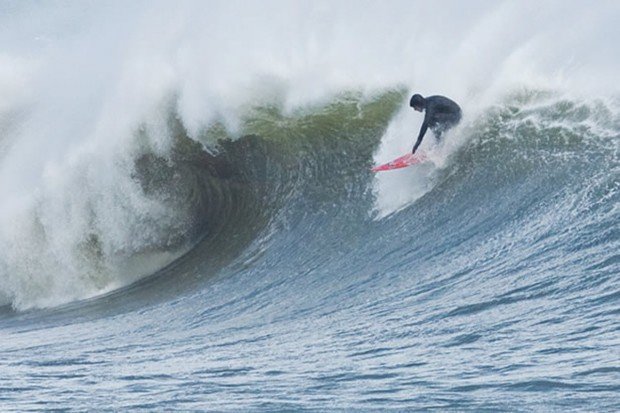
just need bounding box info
[2,84,619,309]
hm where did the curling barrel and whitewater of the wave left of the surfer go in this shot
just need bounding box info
[1,91,402,309]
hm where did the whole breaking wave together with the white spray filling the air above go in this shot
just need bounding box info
[0,2,618,309]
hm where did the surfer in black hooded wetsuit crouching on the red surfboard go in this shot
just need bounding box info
[409,94,461,153]
